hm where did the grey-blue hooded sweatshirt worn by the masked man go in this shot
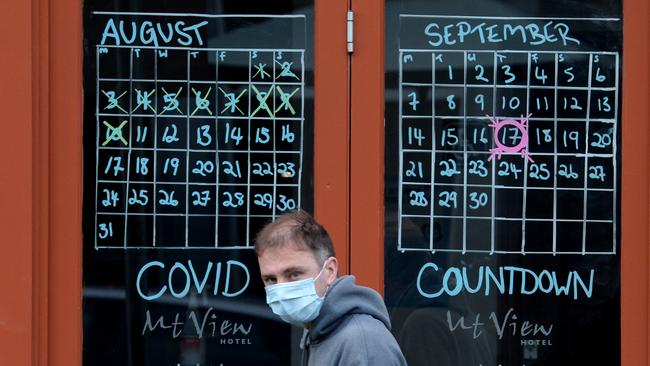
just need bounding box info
[300,276,406,366]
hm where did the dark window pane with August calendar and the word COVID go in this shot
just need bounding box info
[83,0,313,366]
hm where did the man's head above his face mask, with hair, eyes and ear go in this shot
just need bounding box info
[255,210,338,296]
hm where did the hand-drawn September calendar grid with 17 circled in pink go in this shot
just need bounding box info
[397,15,619,255]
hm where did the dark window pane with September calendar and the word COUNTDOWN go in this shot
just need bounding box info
[385,0,622,366]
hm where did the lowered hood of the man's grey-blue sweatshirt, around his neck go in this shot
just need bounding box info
[309,276,390,343]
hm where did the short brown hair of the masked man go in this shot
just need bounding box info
[255,210,336,266]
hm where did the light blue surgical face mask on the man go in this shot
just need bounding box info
[264,264,325,326]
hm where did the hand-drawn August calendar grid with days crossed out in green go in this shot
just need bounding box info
[95,15,304,249]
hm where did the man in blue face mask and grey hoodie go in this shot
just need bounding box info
[255,211,406,366]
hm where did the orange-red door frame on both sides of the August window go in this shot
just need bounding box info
[0,0,350,366]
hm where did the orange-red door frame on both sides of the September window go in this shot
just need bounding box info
[350,0,650,366]
